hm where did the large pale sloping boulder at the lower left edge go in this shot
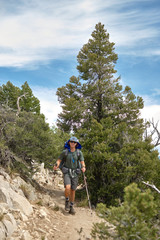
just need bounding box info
[0,169,33,240]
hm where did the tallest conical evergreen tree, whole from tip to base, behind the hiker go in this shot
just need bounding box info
[57,23,160,204]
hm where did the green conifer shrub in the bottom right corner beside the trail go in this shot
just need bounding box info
[92,183,160,240]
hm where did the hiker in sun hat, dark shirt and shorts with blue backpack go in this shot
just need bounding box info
[53,137,86,214]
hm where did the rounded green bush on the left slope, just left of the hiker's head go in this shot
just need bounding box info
[2,112,69,167]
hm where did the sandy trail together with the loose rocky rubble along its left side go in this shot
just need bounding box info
[10,183,101,240]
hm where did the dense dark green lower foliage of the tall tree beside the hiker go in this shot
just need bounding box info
[79,118,160,205]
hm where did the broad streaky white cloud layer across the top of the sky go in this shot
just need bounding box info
[0,0,160,67]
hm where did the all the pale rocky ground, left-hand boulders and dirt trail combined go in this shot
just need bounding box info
[0,165,105,240]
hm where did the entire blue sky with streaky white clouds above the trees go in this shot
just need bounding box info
[0,0,160,143]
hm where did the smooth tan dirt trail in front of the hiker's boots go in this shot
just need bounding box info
[49,186,101,240]
